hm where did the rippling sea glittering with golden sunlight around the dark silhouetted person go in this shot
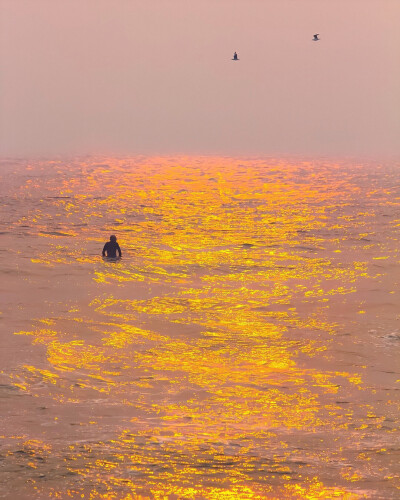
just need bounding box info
[0,158,400,500]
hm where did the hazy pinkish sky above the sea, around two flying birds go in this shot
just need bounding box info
[0,0,400,157]
